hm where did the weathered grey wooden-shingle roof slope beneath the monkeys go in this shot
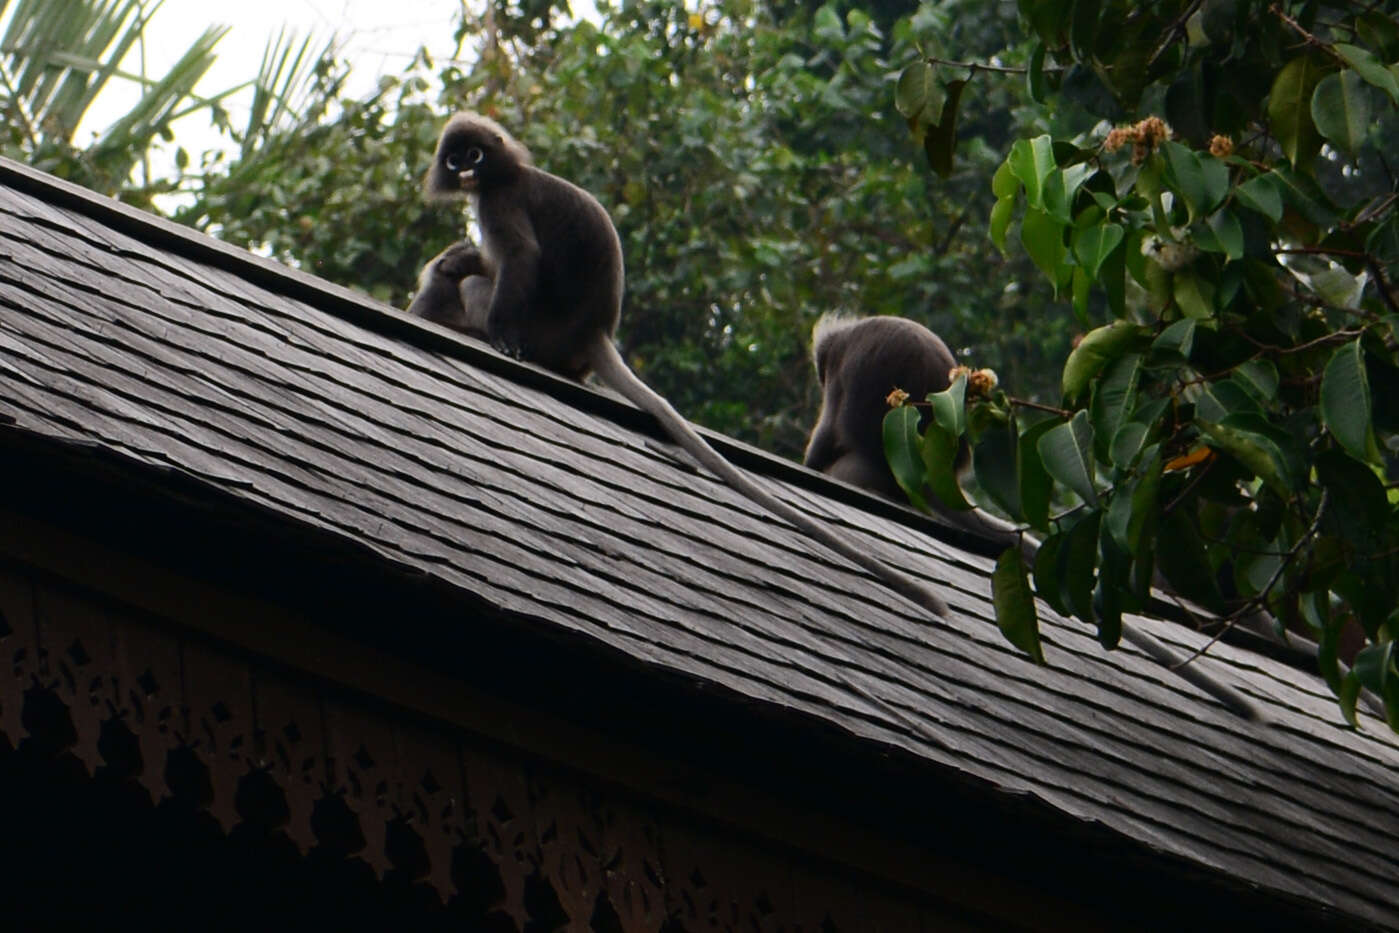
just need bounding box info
[0,162,1399,927]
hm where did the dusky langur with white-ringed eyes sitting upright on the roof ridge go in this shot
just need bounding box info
[411,113,947,615]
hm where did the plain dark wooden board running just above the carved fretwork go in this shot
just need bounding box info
[0,503,1063,929]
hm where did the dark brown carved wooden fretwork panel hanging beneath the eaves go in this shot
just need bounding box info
[0,571,940,933]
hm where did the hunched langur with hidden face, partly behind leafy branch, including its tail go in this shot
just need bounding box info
[804,315,1260,720]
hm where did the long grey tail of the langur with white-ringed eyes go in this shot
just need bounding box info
[592,337,947,617]
